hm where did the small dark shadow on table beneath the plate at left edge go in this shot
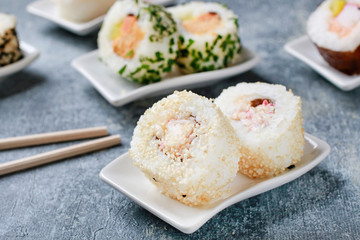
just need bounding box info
[0,69,45,99]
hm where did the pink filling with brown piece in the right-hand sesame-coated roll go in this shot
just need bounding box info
[231,98,275,131]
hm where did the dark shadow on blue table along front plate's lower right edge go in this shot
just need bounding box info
[198,167,345,239]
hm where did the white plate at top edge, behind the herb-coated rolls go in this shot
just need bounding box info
[26,0,175,36]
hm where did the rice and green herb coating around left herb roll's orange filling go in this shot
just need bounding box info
[98,0,178,83]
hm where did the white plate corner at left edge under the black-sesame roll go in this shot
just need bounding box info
[0,41,39,78]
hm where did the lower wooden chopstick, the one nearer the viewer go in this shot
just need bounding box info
[0,135,121,176]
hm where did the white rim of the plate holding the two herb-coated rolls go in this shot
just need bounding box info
[71,46,261,107]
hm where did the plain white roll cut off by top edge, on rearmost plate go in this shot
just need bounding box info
[53,0,116,22]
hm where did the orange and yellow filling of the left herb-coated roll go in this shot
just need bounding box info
[111,14,144,59]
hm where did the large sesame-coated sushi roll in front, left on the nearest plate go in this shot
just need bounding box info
[129,91,241,206]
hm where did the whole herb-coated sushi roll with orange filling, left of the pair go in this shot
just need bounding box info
[98,0,178,84]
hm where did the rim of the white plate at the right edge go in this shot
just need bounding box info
[284,35,360,91]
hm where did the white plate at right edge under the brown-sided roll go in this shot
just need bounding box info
[285,36,360,91]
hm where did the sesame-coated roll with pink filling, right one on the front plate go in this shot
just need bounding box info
[215,83,304,178]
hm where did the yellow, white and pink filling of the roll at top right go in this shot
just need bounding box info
[329,0,360,38]
